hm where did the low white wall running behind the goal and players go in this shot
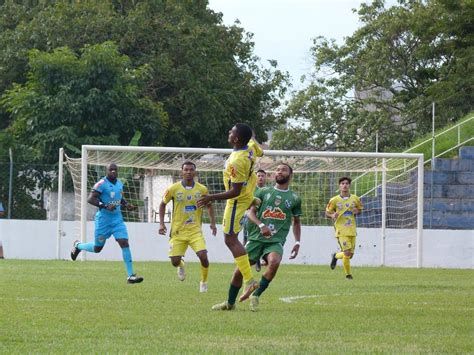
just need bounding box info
[0,219,474,269]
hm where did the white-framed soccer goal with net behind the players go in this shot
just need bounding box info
[58,145,423,267]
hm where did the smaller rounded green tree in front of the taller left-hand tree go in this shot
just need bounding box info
[1,42,167,164]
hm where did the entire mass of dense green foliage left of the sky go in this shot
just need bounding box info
[0,0,288,161]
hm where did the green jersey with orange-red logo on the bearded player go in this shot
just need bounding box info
[248,187,301,244]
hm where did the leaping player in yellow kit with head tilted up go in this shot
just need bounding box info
[198,123,263,302]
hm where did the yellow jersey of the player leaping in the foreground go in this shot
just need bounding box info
[224,139,263,201]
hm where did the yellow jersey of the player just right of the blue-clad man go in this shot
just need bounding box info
[163,181,209,236]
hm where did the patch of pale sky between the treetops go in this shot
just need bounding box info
[209,0,367,89]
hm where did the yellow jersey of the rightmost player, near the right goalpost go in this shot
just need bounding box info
[326,195,363,238]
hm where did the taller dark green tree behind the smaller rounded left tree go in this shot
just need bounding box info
[0,0,288,152]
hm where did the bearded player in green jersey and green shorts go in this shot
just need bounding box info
[212,163,301,311]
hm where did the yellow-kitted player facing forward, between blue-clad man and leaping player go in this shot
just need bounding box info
[158,161,217,292]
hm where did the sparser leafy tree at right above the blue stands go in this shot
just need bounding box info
[272,0,474,151]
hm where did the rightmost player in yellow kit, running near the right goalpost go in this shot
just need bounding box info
[326,177,363,280]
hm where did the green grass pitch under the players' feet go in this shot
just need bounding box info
[0,260,474,354]
